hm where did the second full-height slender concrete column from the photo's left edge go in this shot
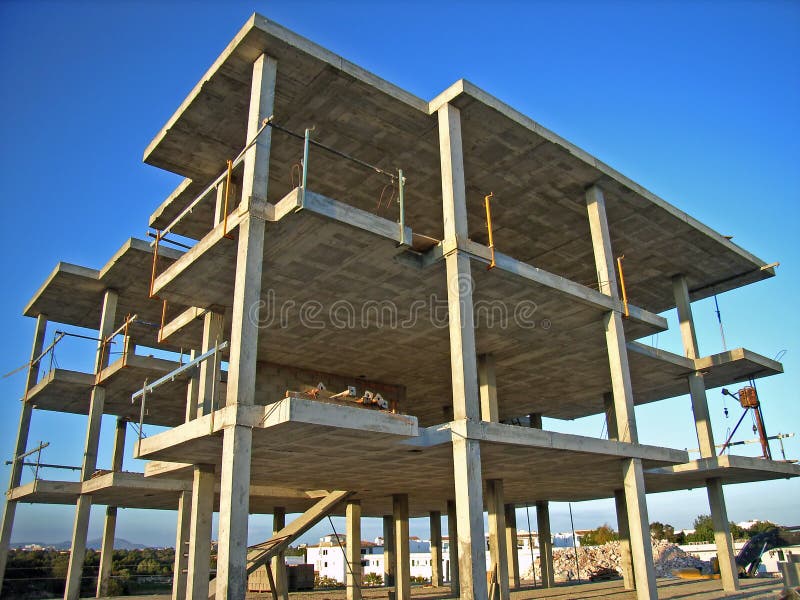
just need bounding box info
[64,290,117,600]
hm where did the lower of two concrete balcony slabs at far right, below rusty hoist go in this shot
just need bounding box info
[645,454,800,492]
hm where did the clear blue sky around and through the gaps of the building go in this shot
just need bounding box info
[0,0,800,545]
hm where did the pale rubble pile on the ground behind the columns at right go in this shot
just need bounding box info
[523,540,711,581]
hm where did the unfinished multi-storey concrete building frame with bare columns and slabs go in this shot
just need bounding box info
[0,15,800,600]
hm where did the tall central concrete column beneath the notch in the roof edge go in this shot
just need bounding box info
[438,104,488,600]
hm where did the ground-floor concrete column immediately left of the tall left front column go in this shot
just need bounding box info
[184,465,215,600]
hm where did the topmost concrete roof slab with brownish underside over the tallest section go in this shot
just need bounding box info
[145,14,774,313]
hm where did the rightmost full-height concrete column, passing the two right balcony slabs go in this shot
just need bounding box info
[672,275,740,592]
